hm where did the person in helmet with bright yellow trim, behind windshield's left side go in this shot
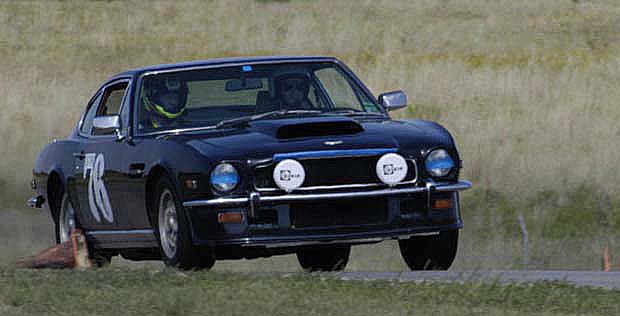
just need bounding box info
[142,77,187,128]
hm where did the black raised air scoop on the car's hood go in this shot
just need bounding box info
[276,119,364,139]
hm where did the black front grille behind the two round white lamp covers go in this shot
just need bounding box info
[254,156,416,190]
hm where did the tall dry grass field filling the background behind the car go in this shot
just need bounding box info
[0,0,620,269]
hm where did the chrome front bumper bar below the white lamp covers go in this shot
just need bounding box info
[183,180,472,216]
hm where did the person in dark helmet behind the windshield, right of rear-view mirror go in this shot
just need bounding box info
[274,73,313,110]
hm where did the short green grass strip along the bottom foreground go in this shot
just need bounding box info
[0,268,620,315]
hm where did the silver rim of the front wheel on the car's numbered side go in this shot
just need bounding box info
[158,189,179,258]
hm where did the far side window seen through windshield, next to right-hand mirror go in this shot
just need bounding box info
[315,67,364,111]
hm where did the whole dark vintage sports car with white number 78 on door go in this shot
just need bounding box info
[29,57,471,270]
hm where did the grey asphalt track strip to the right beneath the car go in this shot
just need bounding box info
[314,270,620,290]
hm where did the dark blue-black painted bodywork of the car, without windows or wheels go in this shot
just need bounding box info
[33,57,471,258]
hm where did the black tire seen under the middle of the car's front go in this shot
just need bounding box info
[297,246,351,272]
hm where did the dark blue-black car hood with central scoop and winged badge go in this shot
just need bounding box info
[165,116,454,161]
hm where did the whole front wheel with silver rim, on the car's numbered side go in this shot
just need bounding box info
[152,176,215,270]
